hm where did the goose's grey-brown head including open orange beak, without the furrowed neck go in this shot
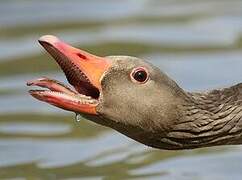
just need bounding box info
[27,35,241,149]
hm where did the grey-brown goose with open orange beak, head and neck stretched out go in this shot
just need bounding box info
[27,35,242,150]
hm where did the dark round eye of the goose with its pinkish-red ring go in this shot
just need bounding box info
[130,67,149,84]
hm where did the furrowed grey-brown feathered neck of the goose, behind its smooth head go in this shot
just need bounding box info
[163,83,242,149]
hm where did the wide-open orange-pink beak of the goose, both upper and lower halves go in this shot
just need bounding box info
[27,35,111,114]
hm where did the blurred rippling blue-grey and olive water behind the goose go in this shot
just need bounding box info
[0,0,242,180]
